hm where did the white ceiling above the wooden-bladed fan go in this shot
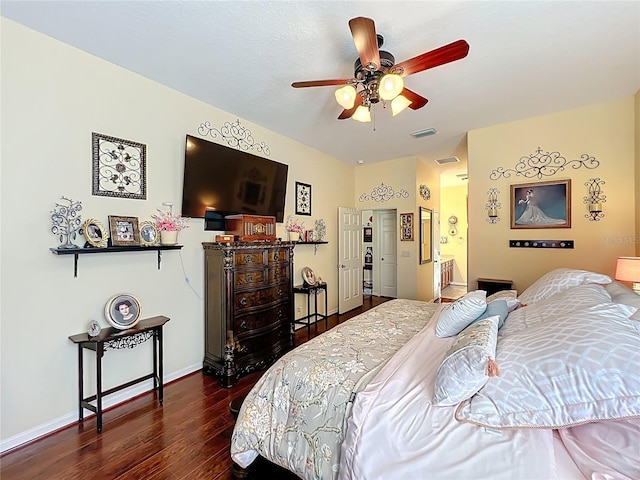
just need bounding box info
[0,0,640,185]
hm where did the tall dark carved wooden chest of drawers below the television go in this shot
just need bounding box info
[202,242,295,388]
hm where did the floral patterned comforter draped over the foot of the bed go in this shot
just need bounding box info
[231,300,439,480]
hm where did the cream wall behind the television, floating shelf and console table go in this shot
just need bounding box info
[0,18,355,450]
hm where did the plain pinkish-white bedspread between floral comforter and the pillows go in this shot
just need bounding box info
[339,319,583,480]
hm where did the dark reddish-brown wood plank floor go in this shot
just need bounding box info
[0,296,389,480]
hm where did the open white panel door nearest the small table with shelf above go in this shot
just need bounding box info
[338,207,362,313]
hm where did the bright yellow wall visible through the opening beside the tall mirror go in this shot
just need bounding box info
[440,185,468,288]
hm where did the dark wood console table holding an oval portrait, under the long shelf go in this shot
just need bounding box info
[69,316,169,433]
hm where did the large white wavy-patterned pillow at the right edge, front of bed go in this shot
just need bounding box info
[455,302,640,428]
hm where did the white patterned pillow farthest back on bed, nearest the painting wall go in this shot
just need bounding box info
[518,268,611,305]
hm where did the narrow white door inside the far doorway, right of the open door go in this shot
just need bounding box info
[374,210,398,298]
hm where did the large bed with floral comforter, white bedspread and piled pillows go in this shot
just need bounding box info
[231,269,640,480]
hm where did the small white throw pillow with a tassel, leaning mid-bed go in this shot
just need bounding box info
[433,315,499,405]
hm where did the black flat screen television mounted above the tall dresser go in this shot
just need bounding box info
[182,135,289,230]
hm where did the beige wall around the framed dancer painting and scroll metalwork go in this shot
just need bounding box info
[468,97,638,291]
